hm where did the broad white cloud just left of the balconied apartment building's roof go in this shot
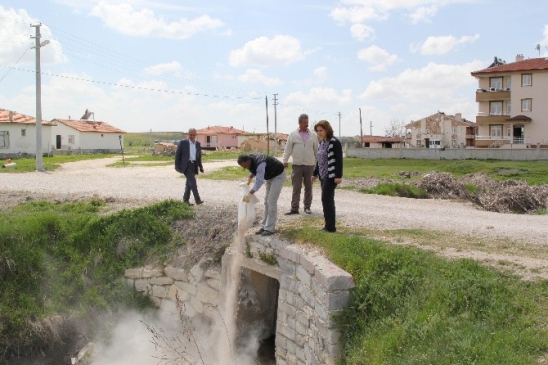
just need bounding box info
[359,61,484,102]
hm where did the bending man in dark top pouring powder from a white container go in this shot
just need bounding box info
[238,152,285,236]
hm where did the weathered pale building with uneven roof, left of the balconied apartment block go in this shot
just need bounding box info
[405,112,476,148]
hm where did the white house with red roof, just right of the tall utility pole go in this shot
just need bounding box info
[51,119,126,153]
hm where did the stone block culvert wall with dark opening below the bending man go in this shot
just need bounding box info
[125,235,354,365]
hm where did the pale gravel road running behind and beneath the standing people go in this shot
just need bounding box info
[0,157,548,245]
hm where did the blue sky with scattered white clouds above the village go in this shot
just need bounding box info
[0,0,548,136]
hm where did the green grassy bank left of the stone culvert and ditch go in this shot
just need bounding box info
[0,200,193,359]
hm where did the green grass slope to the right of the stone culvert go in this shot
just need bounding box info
[285,227,548,365]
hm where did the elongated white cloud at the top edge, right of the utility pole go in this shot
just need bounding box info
[91,1,223,39]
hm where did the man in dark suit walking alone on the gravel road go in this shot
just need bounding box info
[175,128,204,205]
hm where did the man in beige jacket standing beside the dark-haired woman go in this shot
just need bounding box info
[283,114,318,215]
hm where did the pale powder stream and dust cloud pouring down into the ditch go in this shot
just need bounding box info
[86,184,259,365]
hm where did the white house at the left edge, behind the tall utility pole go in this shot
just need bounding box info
[0,109,55,158]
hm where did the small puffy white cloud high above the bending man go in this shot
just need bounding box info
[229,35,304,66]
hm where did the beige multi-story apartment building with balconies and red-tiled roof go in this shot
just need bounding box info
[472,55,548,148]
